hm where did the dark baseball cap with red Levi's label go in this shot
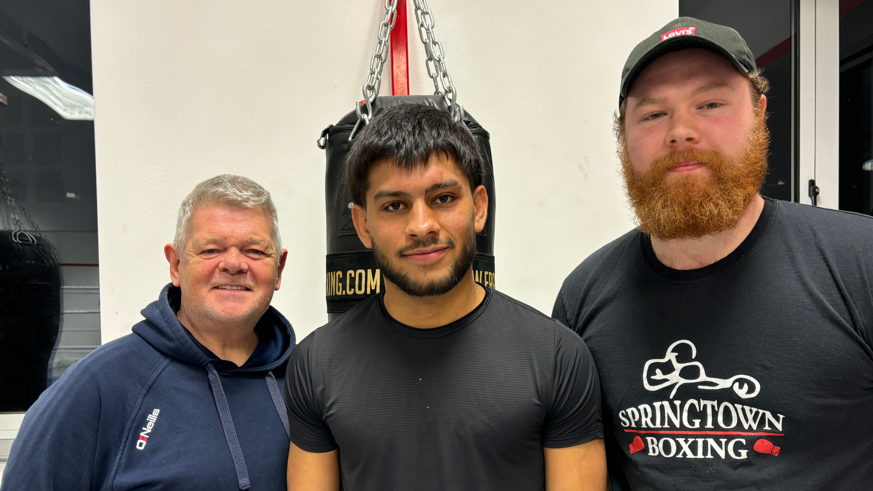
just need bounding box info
[618,17,757,106]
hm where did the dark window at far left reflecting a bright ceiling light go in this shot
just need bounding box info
[0,0,100,416]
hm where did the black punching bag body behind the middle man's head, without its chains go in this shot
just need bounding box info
[319,96,497,319]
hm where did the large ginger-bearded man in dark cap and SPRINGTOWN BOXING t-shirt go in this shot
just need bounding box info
[553,17,873,491]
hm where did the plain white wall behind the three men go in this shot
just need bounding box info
[91,0,678,342]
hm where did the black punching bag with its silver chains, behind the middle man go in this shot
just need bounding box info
[318,0,497,319]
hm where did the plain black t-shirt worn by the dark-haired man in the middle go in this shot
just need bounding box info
[285,290,603,491]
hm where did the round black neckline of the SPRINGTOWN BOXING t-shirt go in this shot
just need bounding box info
[639,198,779,283]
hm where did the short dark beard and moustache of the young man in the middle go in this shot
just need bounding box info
[373,232,476,297]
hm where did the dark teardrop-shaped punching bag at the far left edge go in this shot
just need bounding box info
[0,134,61,413]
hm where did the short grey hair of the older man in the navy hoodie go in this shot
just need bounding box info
[173,174,282,255]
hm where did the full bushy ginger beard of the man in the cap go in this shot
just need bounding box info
[616,112,770,240]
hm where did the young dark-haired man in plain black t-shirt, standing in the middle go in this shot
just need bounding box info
[285,105,606,491]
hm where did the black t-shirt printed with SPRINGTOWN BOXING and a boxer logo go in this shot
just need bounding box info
[553,200,873,491]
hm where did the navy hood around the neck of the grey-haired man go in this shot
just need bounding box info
[133,283,296,374]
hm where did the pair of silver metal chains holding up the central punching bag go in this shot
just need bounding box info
[349,0,464,141]
